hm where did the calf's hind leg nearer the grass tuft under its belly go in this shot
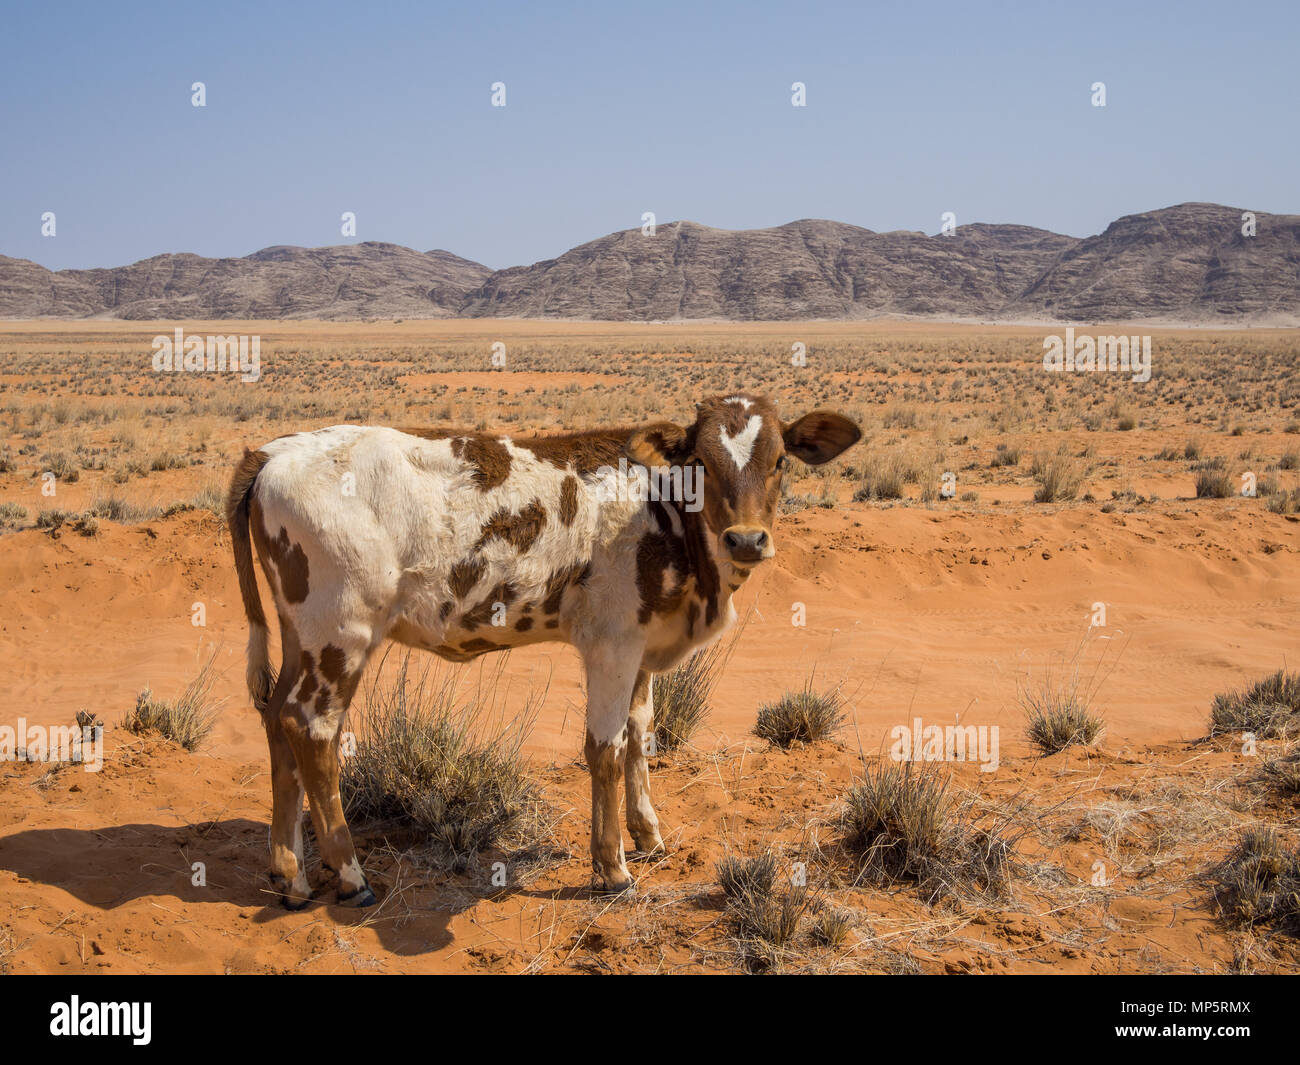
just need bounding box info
[280,642,374,906]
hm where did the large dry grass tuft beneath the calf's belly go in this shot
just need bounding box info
[339,654,540,870]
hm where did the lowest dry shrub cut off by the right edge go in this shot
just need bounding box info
[1210,828,1300,932]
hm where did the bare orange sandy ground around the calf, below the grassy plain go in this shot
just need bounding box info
[0,322,1300,973]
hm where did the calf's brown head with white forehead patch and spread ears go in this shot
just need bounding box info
[627,393,862,567]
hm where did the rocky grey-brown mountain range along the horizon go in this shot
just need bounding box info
[0,203,1300,324]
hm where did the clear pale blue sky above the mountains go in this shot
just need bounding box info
[0,0,1300,268]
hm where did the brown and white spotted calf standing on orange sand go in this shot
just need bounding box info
[226,394,861,908]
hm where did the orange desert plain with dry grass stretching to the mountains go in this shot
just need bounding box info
[0,320,1300,974]
